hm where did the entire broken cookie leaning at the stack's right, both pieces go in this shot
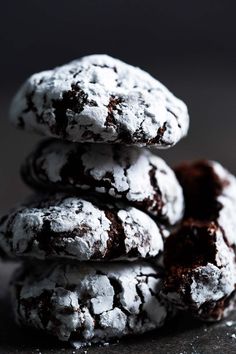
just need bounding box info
[163,161,236,320]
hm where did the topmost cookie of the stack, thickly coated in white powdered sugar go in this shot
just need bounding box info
[10,55,189,148]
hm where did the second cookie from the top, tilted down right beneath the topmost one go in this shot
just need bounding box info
[22,139,184,225]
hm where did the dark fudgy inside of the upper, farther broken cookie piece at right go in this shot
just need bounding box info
[175,160,228,220]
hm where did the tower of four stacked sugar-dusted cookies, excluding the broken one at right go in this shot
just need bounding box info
[0,55,189,342]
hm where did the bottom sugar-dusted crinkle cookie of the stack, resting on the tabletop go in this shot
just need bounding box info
[12,262,171,345]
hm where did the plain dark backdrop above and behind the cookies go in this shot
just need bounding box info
[0,0,236,212]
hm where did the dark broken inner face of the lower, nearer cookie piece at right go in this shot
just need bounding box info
[165,219,217,271]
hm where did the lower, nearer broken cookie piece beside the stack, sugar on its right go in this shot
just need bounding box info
[164,219,236,320]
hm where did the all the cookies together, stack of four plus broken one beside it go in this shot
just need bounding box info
[0,55,236,344]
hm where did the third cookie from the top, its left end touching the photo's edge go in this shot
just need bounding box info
[0,194,165,261]
